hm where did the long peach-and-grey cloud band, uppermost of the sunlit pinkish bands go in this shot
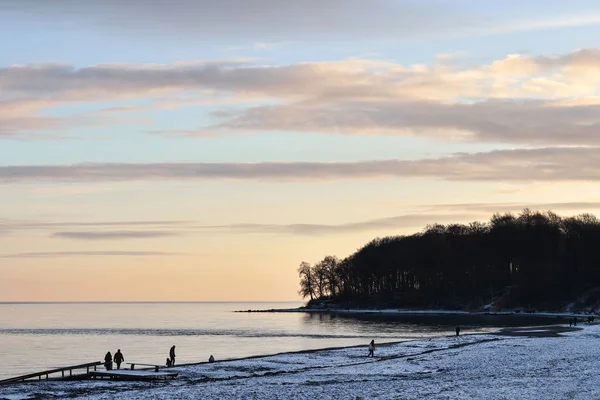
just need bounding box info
[5,49,600,101]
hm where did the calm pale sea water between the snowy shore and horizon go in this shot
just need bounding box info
[0,303,556,379]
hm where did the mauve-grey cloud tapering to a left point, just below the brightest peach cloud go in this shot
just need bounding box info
[205,100,600,145]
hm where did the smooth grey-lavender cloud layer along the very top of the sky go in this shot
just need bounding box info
[7,0,600,43]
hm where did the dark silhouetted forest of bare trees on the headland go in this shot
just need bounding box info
[298,209,600,311]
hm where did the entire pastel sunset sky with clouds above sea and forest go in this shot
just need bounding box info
[0,0,600,301]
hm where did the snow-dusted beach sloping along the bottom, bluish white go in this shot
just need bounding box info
[0,325,600,400]
